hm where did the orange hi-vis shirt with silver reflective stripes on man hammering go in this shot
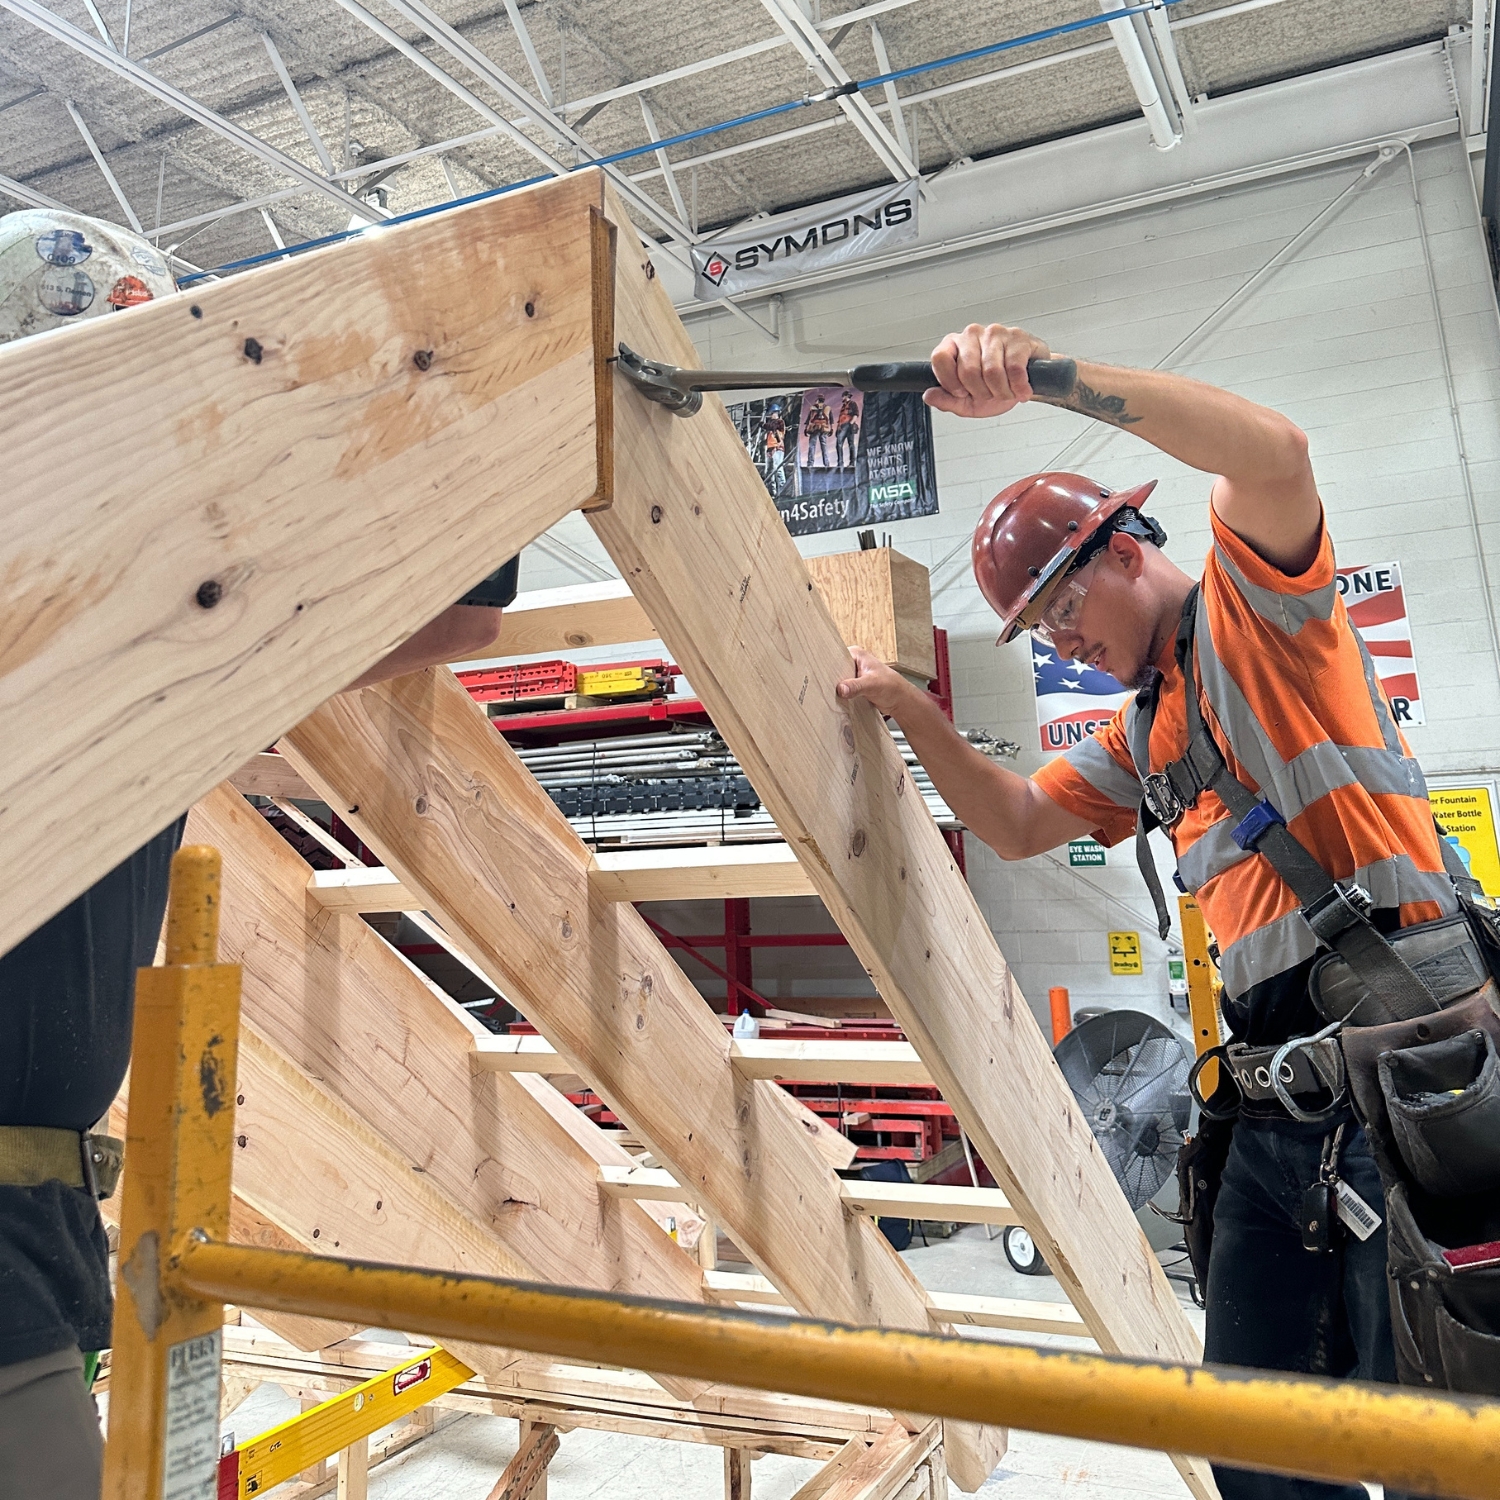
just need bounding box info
[1035,515,1458,996]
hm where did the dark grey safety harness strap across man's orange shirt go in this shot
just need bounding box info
[1136,584,1442,1020]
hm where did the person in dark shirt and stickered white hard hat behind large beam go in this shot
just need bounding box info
[0,210,516,1500]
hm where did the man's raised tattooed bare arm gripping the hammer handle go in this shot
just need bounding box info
[926,323,1323,576]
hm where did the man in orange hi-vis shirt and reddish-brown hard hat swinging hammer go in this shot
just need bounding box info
[839,324,1458,1500]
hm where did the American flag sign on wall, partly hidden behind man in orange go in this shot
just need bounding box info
[1031,563,1427,755]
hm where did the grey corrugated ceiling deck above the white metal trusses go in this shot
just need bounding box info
[0,0,1470,276]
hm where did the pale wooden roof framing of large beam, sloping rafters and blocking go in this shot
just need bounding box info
[14,173,1214,1500]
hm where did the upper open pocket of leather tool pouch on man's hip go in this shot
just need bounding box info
[1376,1029,1500,1197]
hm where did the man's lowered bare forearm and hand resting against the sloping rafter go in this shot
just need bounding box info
[839,647,1089,860]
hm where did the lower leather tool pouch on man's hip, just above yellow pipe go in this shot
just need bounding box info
[1386,1182,1500,1397]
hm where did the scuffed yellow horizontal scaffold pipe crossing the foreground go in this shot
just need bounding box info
[175,1235,1500,1500]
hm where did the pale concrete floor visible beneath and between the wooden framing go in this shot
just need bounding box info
[234,1226,1203,1500]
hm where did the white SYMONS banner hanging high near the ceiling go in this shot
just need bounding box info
[693,180,921,302]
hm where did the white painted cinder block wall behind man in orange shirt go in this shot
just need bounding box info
[507,140,1500,1017]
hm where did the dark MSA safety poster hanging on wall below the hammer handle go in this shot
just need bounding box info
[729,386,938,537]
